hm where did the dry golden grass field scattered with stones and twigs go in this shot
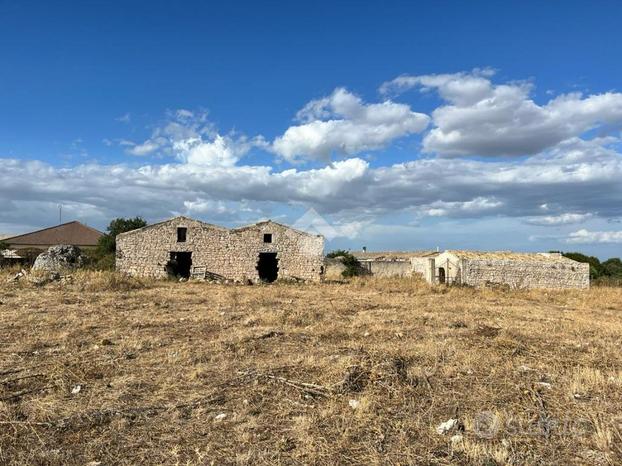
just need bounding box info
[0,272,622,466]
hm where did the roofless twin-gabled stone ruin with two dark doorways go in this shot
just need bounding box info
[116,217,324,282]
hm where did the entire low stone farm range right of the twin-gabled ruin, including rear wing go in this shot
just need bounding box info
[353,250,590,289]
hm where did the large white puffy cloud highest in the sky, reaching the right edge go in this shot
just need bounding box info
[380,70,622,156]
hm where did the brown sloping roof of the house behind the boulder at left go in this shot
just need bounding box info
[3,221,103,248]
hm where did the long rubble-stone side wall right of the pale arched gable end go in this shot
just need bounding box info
[460,259,590,288]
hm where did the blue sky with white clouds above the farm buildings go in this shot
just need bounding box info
[0,1,622,257]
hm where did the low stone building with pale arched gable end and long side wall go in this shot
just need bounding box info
[424,251,590,289]
